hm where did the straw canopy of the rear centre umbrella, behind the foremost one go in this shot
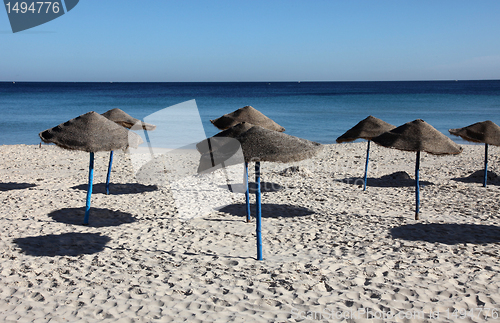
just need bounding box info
[210,105,285,132]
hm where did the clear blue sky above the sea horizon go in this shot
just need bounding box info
[0,0,500,82]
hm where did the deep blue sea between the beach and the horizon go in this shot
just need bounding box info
[0,80,500,145]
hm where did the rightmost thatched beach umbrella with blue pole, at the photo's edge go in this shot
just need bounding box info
[448,120,500,187]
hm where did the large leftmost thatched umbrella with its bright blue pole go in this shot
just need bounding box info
[38,111,142,224]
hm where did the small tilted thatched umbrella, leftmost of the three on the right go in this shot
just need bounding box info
[337,116,396,191]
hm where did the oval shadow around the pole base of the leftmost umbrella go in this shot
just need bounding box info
[48,207,136,228]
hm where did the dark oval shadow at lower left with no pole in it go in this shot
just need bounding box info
[13,233,111,257]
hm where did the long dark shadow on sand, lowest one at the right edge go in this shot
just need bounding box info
[390,223,500,245]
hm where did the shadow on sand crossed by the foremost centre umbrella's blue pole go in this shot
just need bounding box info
[219,203,314,218]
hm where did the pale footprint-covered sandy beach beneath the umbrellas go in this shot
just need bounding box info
[0,143,500,322]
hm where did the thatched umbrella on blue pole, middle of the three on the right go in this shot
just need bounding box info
[372,119,462,220]
